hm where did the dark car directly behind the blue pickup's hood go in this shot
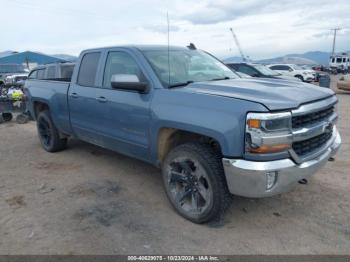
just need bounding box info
[226,63,299,81]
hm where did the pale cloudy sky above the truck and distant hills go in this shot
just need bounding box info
[0,0,350,59]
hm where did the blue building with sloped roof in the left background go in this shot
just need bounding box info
[0,51,67,69]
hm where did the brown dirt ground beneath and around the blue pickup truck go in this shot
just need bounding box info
[0,75,350,254]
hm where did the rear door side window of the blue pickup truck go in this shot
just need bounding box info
[78,52,101,86]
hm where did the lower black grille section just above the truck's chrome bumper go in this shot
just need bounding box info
[292,129,333,156]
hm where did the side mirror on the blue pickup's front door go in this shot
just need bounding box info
[111,74,148,93]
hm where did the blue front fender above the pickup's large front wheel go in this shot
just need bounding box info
[150,89,267,162]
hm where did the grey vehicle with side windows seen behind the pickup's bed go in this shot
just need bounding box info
[28,63,74,82]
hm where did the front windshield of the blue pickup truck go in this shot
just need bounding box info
[143,50,239,87]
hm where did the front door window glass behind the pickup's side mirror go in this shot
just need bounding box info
[103,52,145,88]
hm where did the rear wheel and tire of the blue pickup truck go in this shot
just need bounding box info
[36,110,67,152]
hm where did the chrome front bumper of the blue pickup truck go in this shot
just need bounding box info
[222,128,341,198]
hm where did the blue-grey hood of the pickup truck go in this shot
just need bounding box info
[178,78,334,111]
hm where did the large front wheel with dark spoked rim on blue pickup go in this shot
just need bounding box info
[162,143,232,224]
